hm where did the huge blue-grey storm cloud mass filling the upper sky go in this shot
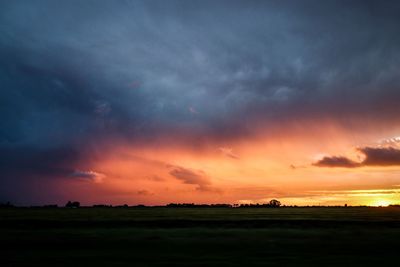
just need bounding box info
[0,0,400,201]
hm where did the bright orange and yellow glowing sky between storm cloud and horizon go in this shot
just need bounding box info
[52,124,400,206]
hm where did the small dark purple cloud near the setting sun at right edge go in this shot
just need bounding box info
[313,147,400,168]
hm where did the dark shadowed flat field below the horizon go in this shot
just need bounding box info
[0,207,400,266]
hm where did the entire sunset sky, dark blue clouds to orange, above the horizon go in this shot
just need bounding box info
[0,0,400,205]
